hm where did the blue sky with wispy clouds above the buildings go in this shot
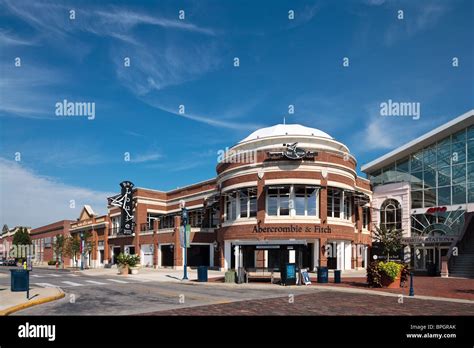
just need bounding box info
[0,0,474,226]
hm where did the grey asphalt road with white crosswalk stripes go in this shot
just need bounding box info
[0,267,315,315]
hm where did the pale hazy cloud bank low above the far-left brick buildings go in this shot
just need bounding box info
[0,158,114,227]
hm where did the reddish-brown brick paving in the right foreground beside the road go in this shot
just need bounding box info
[144,291,474,316]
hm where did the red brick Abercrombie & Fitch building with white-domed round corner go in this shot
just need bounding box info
[101,125,372,269]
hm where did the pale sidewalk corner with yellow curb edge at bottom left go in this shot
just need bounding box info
[0,286,65,316]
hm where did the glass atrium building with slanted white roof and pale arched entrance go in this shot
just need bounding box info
[362,110,474,272]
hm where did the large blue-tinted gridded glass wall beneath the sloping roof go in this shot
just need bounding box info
[369,126,474,205]
